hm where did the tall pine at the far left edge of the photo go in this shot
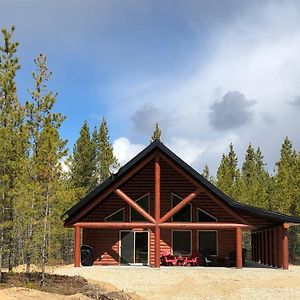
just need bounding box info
[0,27,27,276]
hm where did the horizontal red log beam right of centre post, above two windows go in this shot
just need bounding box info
[159,222,251,230]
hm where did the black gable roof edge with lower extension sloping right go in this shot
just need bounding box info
[62,140,300,223]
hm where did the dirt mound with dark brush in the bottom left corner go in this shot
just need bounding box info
[0,266,136,300]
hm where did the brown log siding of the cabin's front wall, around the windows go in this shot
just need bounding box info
[80,157,269,265]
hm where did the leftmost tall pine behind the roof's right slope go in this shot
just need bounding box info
[216,144,240,198]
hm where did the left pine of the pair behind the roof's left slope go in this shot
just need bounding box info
[71,121,97,193]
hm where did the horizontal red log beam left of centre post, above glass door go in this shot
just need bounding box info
[74,222,155,229]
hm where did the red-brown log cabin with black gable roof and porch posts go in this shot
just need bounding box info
[64,141,300,269]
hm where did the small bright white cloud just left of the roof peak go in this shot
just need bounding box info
[113,137,145,166]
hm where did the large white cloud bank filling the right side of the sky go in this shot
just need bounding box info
[110,1,300,172]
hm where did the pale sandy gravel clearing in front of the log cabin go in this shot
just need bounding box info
[54,266,300,300]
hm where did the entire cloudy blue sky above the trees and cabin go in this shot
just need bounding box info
[0,0,300,172]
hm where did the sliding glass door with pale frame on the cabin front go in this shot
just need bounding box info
[120,230,149,265]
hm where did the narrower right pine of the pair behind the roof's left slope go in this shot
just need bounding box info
[97,117,118,183]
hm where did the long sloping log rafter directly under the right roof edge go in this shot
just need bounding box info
[161,153,251,225]
